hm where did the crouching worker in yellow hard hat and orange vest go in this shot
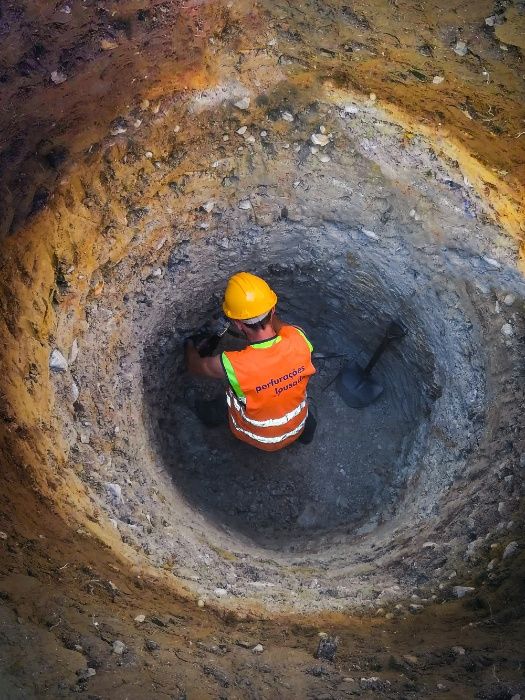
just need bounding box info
[186,272,316,452]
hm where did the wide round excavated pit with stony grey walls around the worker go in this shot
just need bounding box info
[56,106,523,611]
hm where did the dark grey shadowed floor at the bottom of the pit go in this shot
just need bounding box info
[143,290,432,551]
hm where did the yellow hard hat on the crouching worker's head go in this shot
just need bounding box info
[222,272,277,321]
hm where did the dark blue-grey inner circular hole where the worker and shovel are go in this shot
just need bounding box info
[144,232,437,551]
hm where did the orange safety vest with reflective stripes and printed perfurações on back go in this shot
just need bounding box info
[221,326,315,452]
